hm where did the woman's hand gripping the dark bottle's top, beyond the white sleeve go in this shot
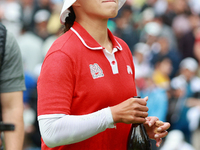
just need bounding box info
[110,97,148,124]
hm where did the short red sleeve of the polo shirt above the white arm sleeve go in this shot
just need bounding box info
[37,50,75,115]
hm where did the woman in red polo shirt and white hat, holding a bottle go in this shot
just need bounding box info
[37,0,170,150]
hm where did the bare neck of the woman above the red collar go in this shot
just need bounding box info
[76,18,112,52]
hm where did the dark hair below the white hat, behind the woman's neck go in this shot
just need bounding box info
[64,6,76,33]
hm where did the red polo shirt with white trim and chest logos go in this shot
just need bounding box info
[38,22,136,150]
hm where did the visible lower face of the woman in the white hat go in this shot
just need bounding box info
[74,0,119,19]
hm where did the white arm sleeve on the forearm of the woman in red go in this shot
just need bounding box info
[38,107,115,147]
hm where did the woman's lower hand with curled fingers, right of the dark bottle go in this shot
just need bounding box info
[144,117,170,147]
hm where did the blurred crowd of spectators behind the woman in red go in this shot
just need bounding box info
[0,0,200,150]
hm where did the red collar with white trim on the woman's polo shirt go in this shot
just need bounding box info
[70,21,122,50]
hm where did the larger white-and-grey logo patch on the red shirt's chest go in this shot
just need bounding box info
[90,63,104,79]
